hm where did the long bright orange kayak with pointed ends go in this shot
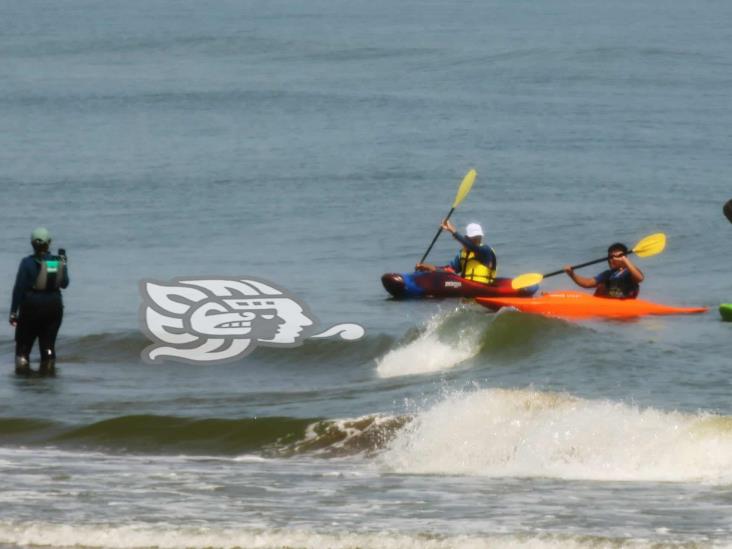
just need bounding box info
[475,291,707,318]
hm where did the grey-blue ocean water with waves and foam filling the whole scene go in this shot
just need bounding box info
[0,0,732,549]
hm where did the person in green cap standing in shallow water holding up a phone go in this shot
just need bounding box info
[10,227,69,376]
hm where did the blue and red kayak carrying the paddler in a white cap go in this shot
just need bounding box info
[381,271,539,299]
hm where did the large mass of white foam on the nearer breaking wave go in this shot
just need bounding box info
[380,389,732,483]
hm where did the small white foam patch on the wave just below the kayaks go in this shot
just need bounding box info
[376,309,482,378]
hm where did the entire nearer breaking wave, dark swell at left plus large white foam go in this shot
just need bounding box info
[0,389,732,484]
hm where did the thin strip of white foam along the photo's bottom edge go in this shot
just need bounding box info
[0,522,708,549]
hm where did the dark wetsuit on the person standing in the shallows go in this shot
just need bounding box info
[10,254,69,373]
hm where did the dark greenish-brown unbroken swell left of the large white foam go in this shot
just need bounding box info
[0,415,410,457]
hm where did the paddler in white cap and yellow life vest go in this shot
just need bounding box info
[415,219,498,284]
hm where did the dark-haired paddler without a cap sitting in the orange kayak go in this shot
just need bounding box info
[564,242,645,299]
